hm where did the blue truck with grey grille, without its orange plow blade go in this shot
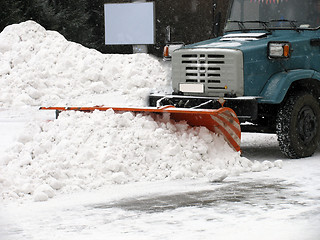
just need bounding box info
[150,0,320,158]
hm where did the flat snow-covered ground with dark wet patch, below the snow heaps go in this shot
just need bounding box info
[0,118,320,240]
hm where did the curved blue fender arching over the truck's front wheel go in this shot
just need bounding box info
[259,69,320,104]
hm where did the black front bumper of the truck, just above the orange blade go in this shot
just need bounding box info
[149,94,258,122]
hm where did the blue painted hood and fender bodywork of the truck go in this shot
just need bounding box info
[186,29,320,103]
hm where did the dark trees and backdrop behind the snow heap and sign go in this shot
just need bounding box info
[0,0,229,56]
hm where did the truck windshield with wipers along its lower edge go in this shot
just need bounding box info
[225,0,320,31]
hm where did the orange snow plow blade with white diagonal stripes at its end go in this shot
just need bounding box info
[40,106,241,151]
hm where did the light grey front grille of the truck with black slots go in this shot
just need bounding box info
[172,49,243,96]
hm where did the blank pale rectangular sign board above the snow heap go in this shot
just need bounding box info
[104,2,155,45]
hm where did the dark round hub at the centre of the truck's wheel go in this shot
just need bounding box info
[297,106,318,144]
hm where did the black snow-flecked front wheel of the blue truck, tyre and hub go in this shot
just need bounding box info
[276,93,320,158]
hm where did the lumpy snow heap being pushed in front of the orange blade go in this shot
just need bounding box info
[0,110,280,201]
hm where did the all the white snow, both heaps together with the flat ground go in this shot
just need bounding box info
[0,21,320,240]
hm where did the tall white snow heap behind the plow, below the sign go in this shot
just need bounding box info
[0,21,168,108]
